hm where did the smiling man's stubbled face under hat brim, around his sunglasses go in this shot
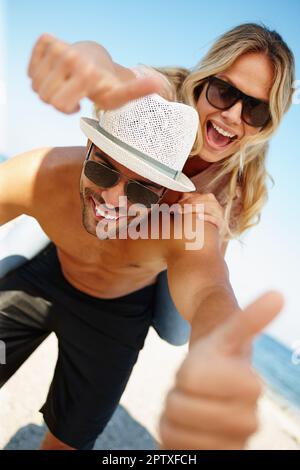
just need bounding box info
[80,145,165,235]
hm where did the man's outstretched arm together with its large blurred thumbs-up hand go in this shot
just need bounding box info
[159,218,282,450]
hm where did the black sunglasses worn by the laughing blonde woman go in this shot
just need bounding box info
[206,77,271,127]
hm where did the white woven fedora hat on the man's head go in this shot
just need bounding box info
[80,94,199,192]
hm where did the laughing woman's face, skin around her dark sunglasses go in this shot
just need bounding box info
[197,53,273,162]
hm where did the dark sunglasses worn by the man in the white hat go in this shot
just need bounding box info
[83,144,166,208]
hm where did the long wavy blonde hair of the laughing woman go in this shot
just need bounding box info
[156,23,295,239]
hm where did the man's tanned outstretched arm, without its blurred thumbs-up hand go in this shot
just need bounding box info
[167,222,239,345]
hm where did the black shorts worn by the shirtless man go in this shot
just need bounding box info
[0,244,154,449]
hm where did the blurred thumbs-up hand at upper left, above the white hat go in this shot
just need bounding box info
[28,34,163,114]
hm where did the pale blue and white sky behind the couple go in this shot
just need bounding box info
[0,0,300,344]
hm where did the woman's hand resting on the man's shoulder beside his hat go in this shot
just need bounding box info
[178,192,225,234]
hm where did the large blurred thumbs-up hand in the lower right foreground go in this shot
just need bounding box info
[160,292,283,449]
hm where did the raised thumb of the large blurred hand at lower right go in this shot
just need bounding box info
[216,291,284,354]
